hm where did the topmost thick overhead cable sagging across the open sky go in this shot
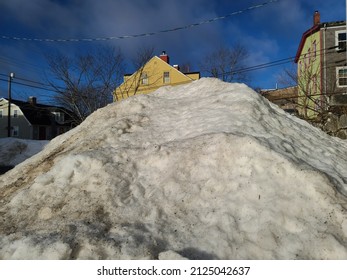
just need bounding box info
[0,0,280,43]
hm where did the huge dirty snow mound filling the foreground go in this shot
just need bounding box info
[0,79,347,259]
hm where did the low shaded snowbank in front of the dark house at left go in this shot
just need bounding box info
[0,138,49,166]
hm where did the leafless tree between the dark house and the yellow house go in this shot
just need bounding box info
[47,48,125,124]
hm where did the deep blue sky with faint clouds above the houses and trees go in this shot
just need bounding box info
[0,0,346,103]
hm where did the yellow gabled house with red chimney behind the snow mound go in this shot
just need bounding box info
[113,52,200,101]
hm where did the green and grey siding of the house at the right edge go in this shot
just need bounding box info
[296,22,347,119]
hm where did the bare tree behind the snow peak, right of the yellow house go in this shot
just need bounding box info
[200,44,249,82]
